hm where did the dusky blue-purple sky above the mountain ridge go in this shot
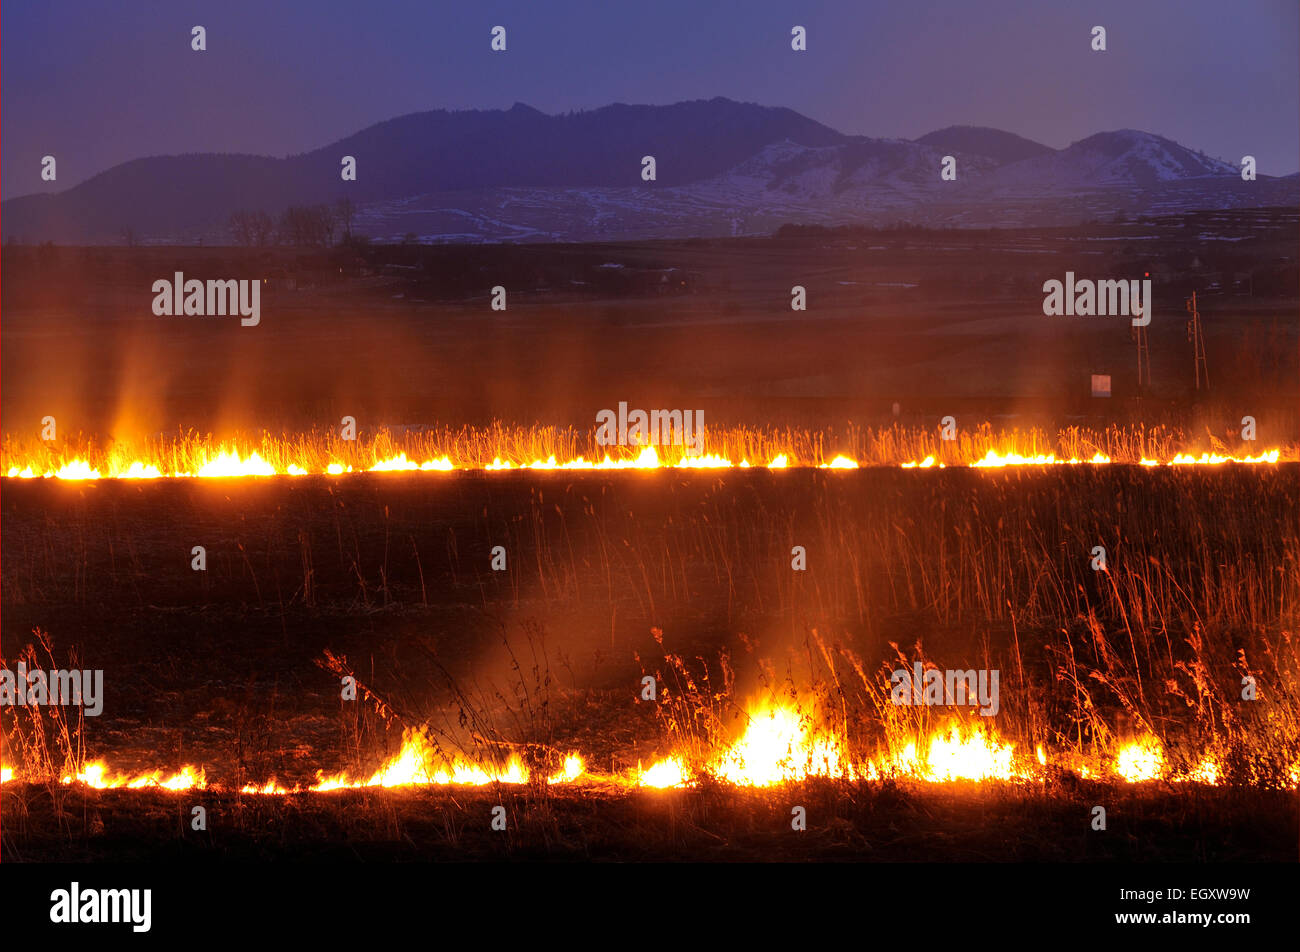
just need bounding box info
[0,0,1300,198]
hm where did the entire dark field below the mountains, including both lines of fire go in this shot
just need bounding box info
[0,221,1300,862]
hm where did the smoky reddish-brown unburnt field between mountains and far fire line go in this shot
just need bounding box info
[0,209,1300,434]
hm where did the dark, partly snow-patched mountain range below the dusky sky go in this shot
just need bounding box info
[0,98,1300,243]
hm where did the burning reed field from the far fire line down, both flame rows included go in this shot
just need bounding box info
[0,427,1300,860]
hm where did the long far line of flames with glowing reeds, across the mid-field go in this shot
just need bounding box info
[3,425,1279,480]
